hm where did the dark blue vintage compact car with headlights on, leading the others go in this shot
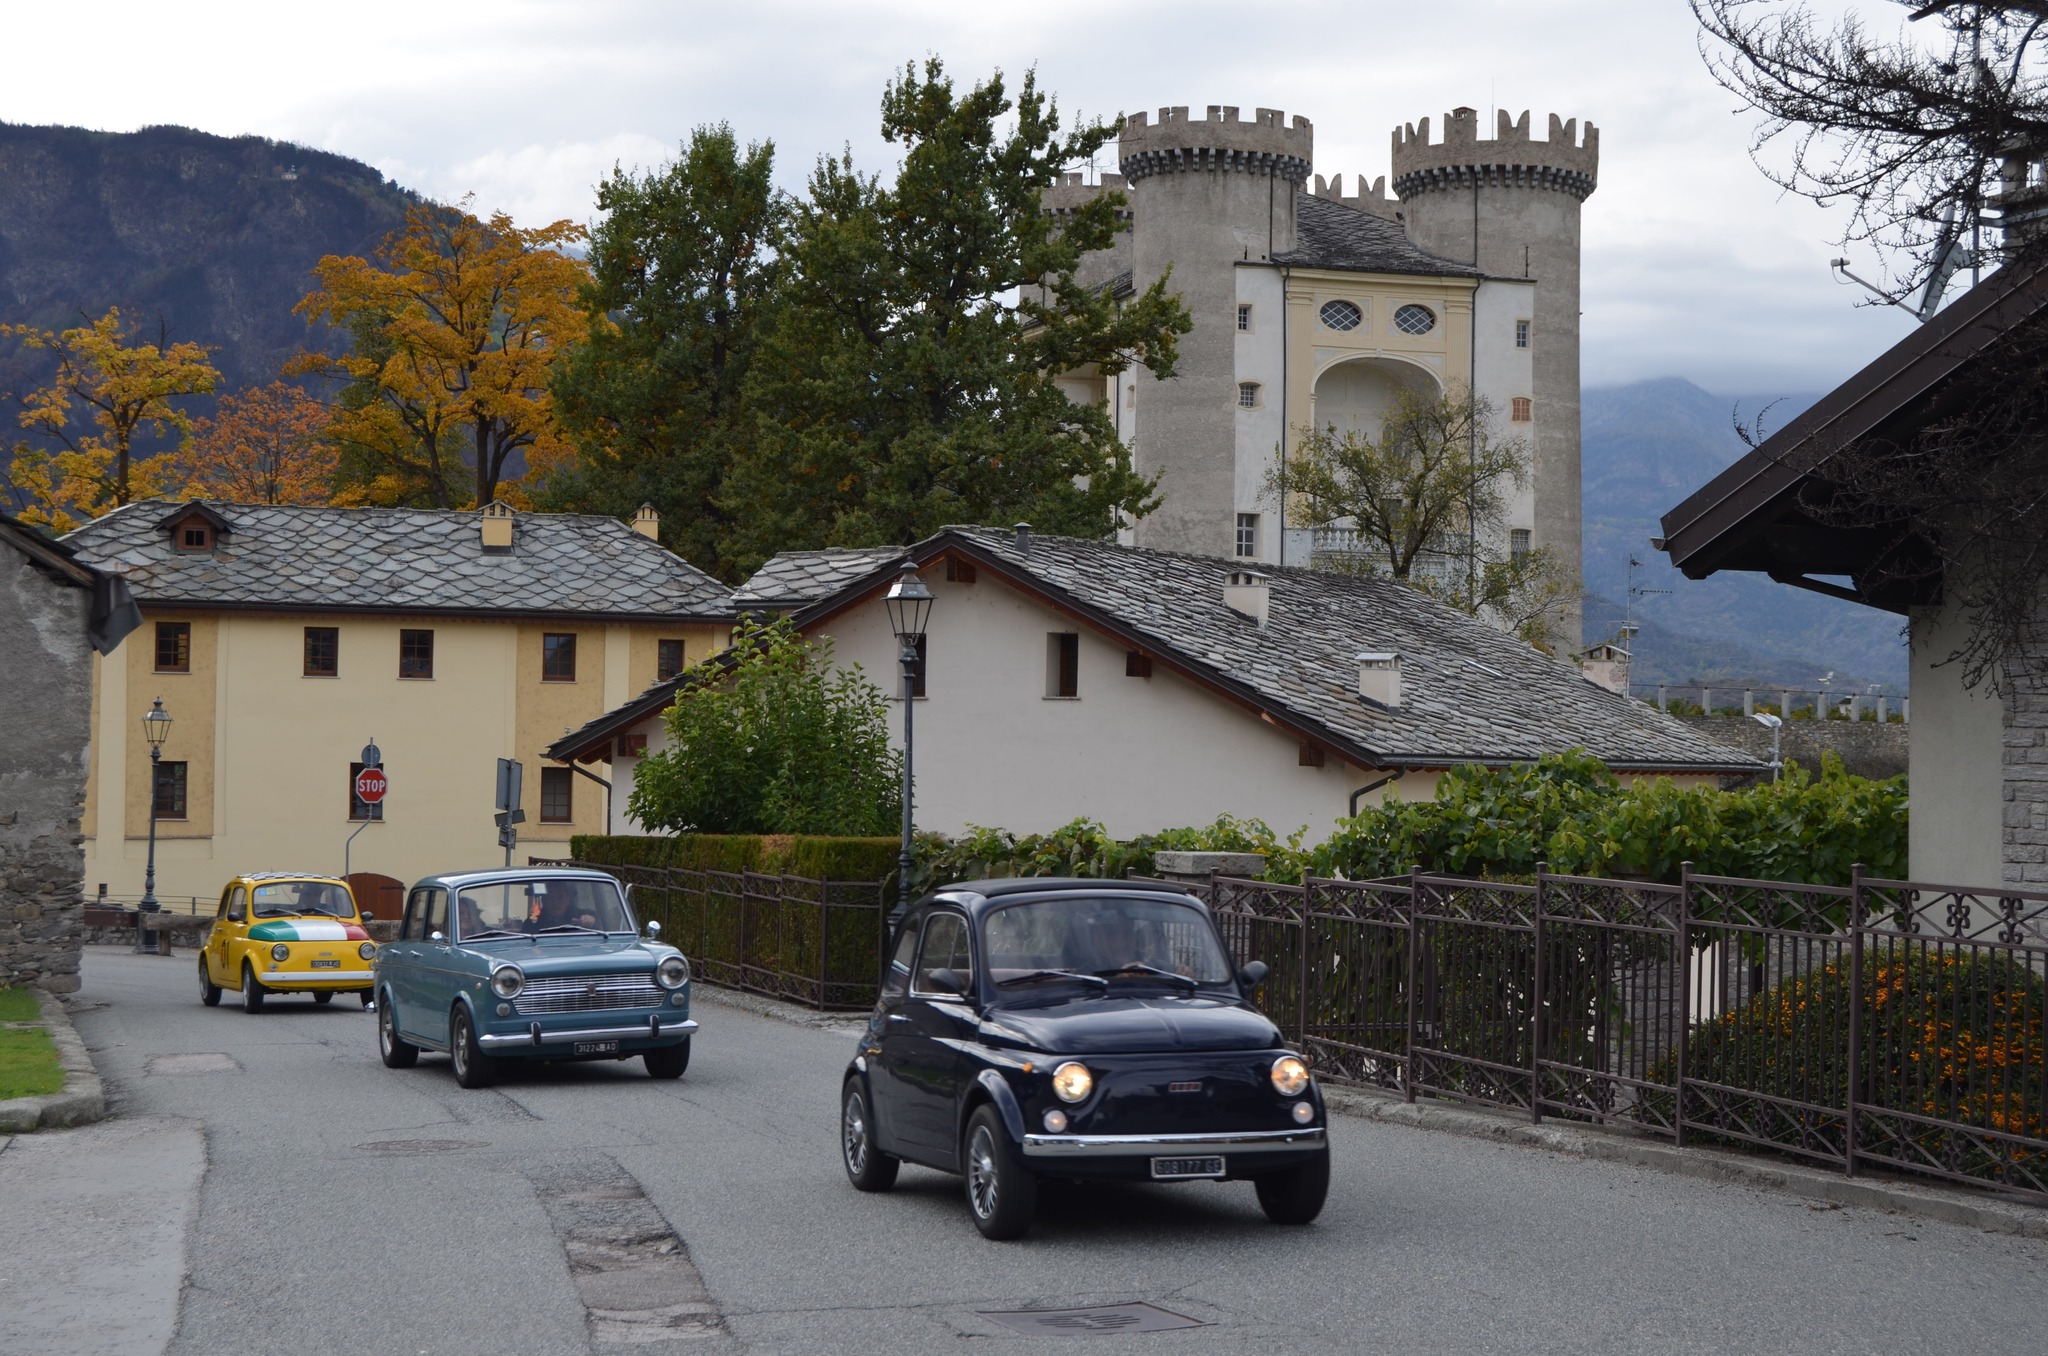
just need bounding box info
[840,879,1329,1239]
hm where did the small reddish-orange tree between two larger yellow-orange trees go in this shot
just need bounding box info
[178,381,336,504]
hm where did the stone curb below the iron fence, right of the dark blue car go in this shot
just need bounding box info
[1323,1084,2048,1239]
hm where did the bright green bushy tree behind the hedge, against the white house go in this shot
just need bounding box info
[627,619,901,836]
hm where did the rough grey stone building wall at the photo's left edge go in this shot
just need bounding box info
[0,549,92,993]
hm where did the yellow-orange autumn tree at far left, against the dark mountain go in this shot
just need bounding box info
[0,309,221,533]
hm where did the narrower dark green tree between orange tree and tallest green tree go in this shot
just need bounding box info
[537,123,788,578]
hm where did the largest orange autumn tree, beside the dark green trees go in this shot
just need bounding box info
[291,205,590,508]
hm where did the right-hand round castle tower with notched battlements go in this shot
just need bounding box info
[1393,109,1599,649]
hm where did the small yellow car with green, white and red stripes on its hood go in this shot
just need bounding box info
[199,871,377,1012]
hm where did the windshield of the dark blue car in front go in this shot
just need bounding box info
[981,895,1231,989]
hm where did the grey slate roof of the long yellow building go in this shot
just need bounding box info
[63,500,733,621]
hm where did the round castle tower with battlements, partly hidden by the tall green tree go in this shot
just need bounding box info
[1118,104,1313,555]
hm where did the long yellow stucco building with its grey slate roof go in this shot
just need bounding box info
[66,502,731,909]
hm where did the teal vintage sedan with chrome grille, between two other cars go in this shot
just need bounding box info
[375,868,696,1088]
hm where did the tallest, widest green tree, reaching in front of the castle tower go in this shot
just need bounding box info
[725,57,1192,565]
